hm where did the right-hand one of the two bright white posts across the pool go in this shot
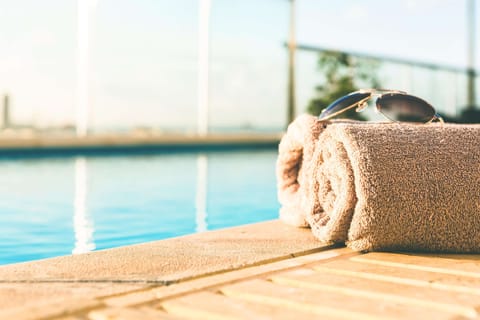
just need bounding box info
[197,0,211,136]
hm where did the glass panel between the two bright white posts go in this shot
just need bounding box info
[91,0,198,131]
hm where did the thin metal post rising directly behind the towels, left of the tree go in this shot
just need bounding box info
[287,0,296,126]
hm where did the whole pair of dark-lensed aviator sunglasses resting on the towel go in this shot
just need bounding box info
[318,89,444,123]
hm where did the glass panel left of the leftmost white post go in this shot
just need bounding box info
[0,0,76,134]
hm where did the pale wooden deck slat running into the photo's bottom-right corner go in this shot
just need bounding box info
[271,269,479,318]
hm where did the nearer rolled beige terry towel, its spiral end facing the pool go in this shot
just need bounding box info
[277,115,480,253]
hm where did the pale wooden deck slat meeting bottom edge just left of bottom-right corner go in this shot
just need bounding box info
[221,280,451,319]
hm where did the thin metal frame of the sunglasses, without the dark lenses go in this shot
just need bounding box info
[318,89,444,124]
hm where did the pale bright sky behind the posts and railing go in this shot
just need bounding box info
[0,0,480,130]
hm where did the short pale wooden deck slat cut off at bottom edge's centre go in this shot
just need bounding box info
[161,291,322,320]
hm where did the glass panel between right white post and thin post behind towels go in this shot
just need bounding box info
[210,0,289,131]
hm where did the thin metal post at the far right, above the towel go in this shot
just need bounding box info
[467,0,476,109]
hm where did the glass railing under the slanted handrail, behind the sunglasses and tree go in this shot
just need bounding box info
[297,45,480,120]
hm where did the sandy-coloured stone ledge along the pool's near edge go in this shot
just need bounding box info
[0,220,325,310]
